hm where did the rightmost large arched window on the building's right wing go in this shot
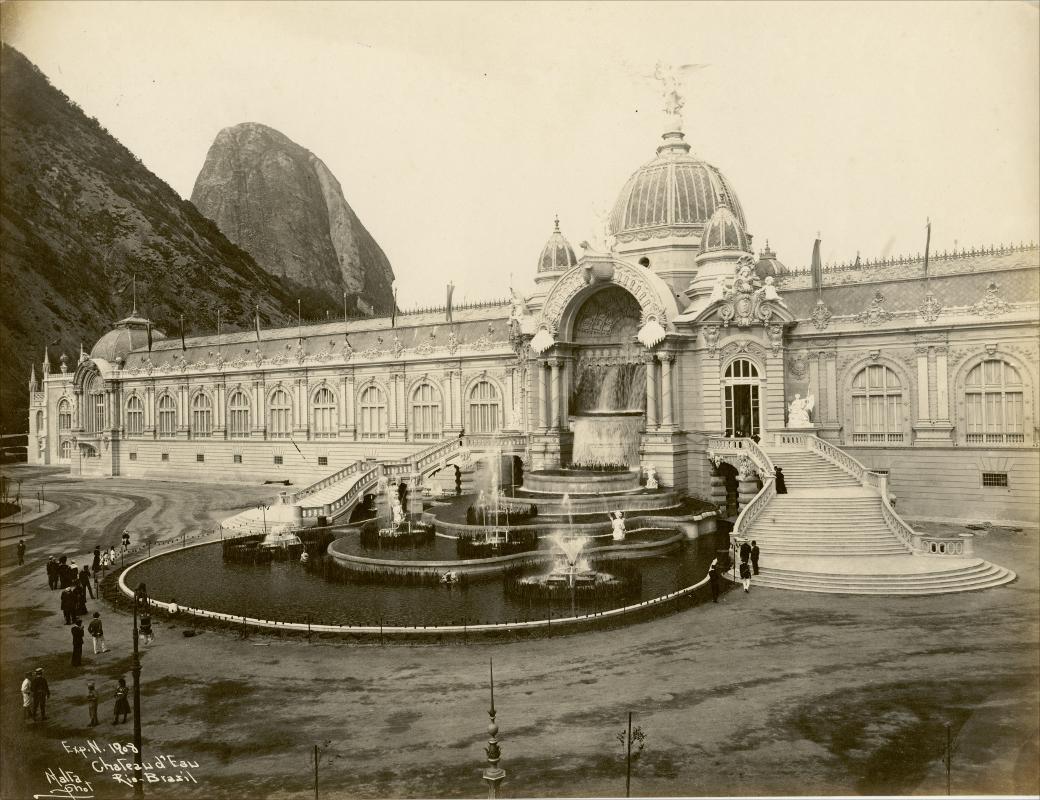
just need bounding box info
[964,359,1025,444]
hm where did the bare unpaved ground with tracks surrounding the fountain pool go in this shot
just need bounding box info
[0,467,1040,800]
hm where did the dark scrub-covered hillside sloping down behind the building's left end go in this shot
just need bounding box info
[0,45,332,433]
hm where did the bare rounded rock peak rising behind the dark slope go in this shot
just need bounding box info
[191,123,393,313]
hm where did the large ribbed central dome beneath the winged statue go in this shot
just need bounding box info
[610,131,747,242]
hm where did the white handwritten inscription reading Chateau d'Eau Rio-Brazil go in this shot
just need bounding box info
[47,739,199,800]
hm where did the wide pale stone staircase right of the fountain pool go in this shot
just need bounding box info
[738,442,1015,595]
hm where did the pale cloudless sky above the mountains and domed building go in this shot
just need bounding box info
[3,2,1040,307]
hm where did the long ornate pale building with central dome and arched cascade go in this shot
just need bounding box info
[29,121,1040,521]
